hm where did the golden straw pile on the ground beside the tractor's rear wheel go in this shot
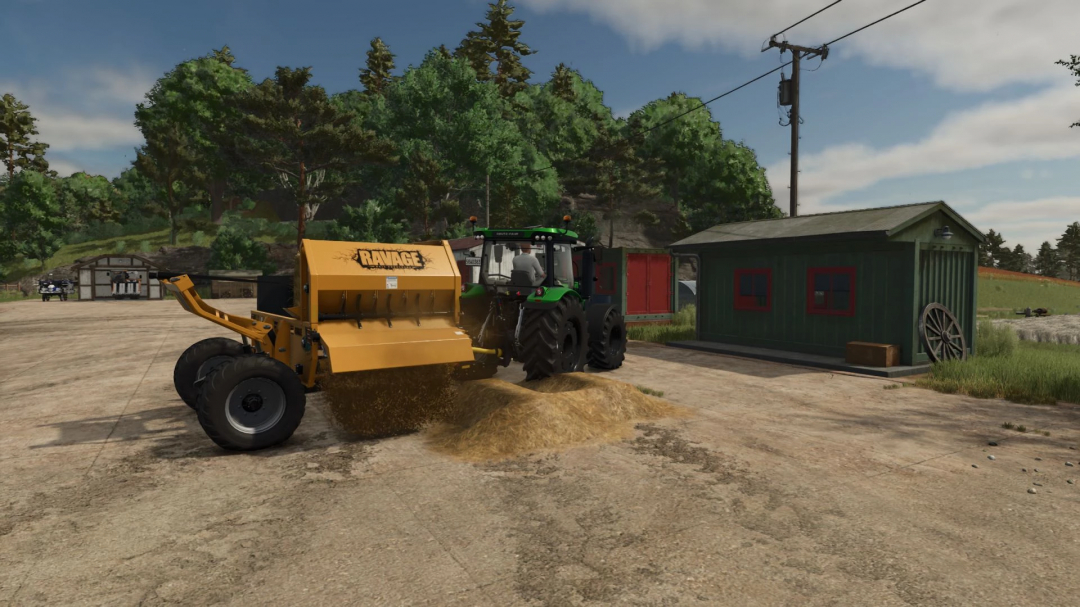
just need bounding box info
[426,373,686,461]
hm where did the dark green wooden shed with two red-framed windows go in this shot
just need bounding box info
[671,202,985,366]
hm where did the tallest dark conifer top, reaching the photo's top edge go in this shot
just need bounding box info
[457,0,535,98]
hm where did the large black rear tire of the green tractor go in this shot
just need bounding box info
[519,297,589,381]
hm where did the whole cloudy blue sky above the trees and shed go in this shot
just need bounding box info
[0,0,1080,249]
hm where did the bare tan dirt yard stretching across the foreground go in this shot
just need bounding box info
[0,301,1080,607]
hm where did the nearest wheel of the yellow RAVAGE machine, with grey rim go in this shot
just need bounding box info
[195,356,307,451]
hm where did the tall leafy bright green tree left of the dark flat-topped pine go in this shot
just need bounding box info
[135,46,254,221]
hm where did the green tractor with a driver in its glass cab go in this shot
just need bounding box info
[461,216,626,380]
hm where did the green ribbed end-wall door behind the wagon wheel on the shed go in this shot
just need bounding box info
[916,248,975,353]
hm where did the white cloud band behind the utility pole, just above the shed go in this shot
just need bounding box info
[768,86,1080,213]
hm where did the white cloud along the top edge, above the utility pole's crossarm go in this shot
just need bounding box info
[521,0,1080,91]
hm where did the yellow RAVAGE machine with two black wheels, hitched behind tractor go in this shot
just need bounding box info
[162,240,477,450]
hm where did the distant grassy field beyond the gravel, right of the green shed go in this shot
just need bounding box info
[978,268,1080,318]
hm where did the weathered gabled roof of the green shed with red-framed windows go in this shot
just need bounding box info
[671,201,986,248]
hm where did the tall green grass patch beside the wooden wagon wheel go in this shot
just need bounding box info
[917,341,1080,403]
